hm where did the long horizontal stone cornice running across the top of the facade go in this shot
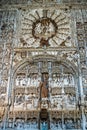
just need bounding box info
[0,3,87,11]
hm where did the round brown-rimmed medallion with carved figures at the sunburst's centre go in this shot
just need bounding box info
[32,18,57,46]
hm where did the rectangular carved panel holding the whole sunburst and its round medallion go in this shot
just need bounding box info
[20,9,73,47]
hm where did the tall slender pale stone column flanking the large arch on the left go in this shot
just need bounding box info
[3,41,14,130]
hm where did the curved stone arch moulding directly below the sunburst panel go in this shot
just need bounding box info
[14,55,78,76]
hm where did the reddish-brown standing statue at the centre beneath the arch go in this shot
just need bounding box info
[40,74,48,99]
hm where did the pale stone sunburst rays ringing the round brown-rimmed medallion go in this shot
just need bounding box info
[22,9,70,47]
